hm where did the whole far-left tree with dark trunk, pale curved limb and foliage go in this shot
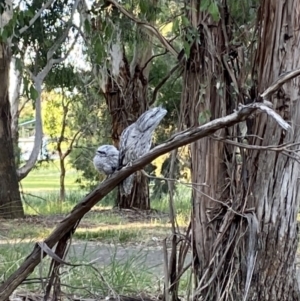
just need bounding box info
[0,0,79,218]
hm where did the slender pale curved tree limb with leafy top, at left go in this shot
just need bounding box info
[18,0,79,180]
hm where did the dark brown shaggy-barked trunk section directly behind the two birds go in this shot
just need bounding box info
[105,48,150,210]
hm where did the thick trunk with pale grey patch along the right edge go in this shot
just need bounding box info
[247,0,300,300]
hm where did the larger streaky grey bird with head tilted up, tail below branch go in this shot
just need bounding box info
[119,107,167,195]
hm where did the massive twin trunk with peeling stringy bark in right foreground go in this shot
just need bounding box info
[181,0,300,301]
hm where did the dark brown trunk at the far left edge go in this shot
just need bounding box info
[0,43,24,218]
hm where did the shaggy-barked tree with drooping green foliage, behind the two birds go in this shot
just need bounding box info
[81,0,180,209]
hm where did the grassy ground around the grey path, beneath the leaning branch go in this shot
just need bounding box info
[0,162,191,297]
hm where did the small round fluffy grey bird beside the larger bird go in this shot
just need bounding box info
[93,145,119,176]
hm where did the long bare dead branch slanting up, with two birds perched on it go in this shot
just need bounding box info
[0,103,290,301]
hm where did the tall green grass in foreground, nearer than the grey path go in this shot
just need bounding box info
[0,242,153,297]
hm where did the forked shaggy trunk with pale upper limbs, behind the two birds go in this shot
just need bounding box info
[102,0,157,210]
